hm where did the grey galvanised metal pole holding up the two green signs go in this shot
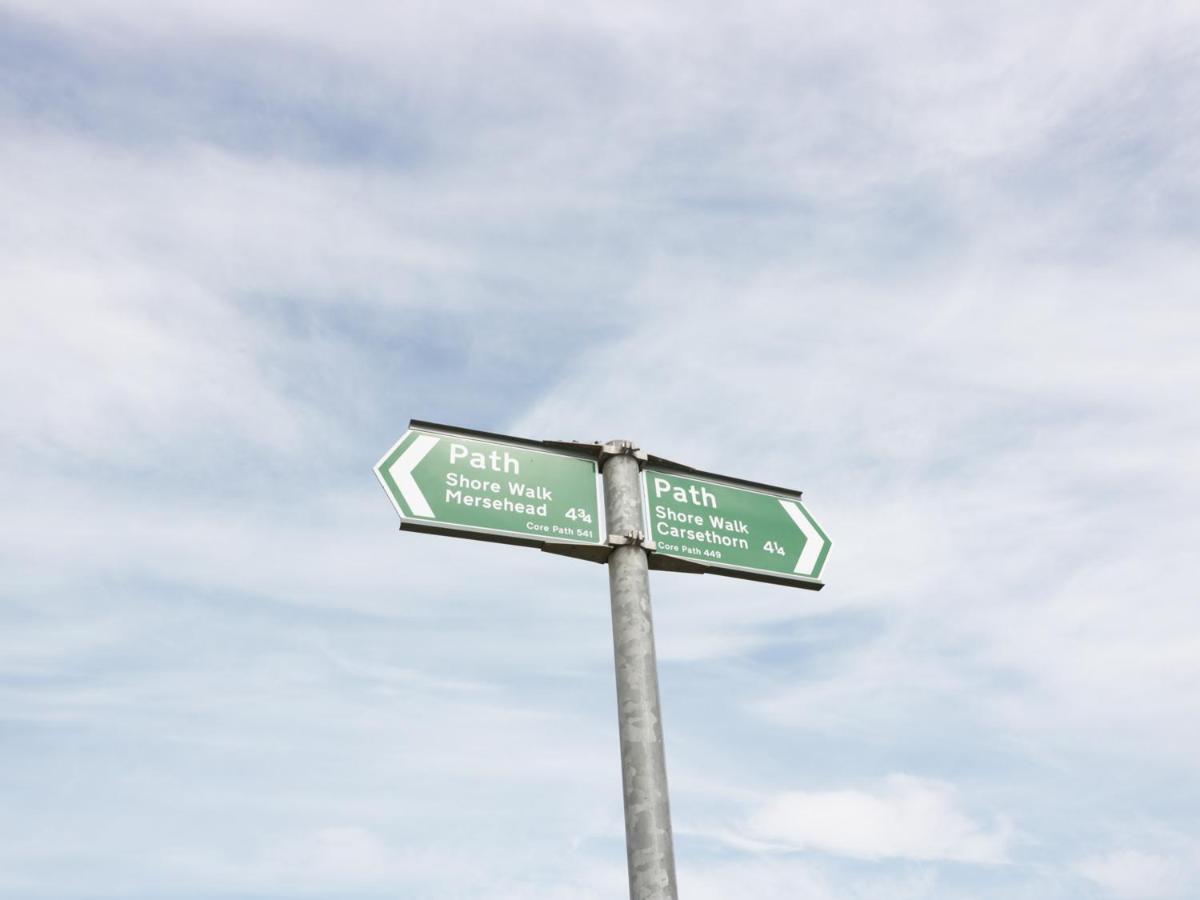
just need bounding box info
[602,442,679,900]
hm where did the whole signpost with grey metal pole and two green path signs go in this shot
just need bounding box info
[376,421,829,900]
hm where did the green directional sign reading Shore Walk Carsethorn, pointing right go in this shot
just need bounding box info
[642,464,829,589]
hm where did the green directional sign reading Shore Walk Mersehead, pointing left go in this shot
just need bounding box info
[376,422,604,545]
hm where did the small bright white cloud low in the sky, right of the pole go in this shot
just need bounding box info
[748,775,1010,863]
